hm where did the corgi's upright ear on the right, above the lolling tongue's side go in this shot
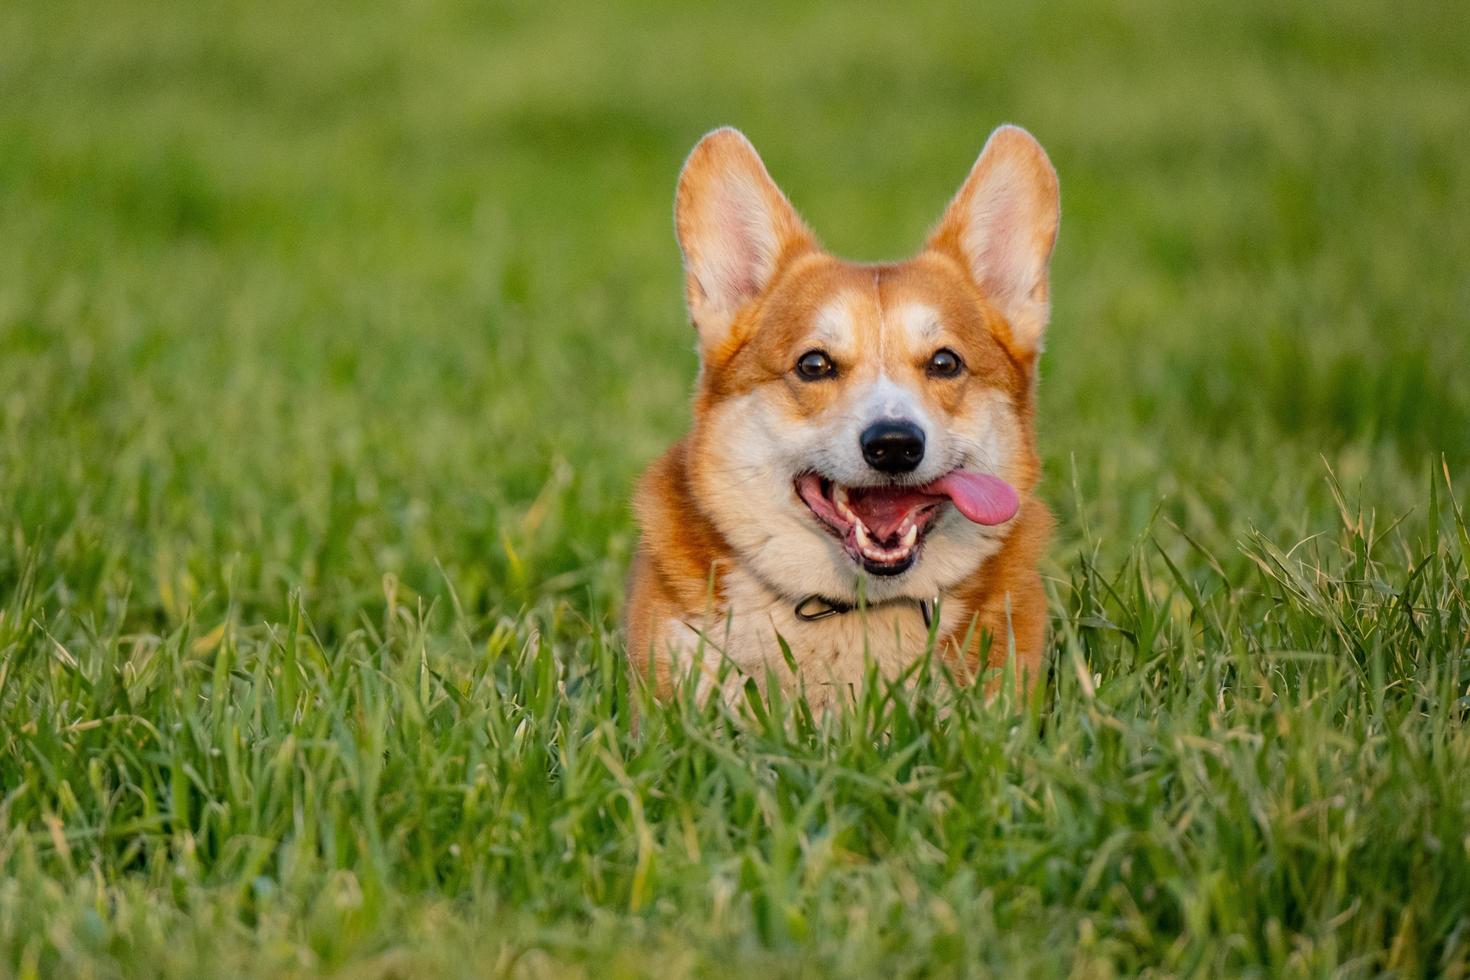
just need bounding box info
[929,126,1061,354]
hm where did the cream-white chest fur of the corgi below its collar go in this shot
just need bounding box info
[669,572,969,707]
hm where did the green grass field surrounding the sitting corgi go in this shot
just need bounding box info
[0,0,1470,977]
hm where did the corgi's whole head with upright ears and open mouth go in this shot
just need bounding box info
[676,126,1058,601]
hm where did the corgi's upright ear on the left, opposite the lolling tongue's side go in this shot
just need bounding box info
[673,126,816,351]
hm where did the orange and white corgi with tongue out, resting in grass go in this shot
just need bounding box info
[626,126,1060,707]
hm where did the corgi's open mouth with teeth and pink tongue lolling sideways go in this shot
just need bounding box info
[797,470,1020,574]
